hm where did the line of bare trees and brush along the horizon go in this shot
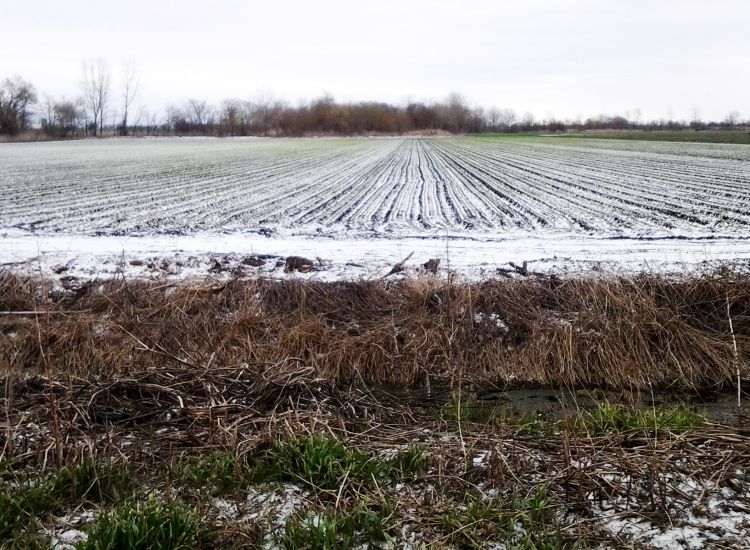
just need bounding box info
[0,59,750,139]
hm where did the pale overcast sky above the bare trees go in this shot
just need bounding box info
[5,0,750,123]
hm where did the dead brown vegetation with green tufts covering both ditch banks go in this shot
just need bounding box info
[0,272,750,548]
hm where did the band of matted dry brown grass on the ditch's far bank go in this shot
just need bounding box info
[0,271,750,391]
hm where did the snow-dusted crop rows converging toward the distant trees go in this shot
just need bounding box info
[0,138,750,236]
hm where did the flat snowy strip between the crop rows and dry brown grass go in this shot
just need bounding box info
[0,232,750,281]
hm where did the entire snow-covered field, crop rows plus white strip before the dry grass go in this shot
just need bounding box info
[0,137,750,278]
